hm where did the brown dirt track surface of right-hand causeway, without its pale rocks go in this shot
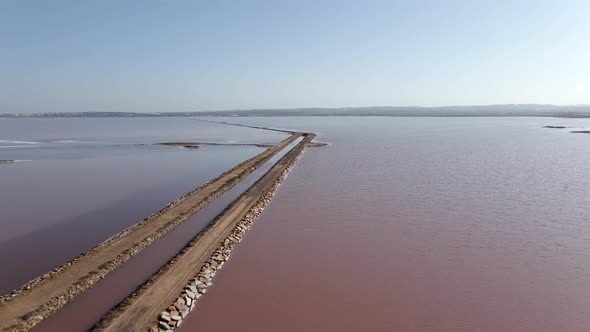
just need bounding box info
[94,134,315,331]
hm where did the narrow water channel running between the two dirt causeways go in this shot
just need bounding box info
[33,139,301,332]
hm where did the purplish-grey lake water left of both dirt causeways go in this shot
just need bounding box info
[0,118,285,294]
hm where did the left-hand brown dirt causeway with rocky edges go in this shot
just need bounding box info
[0,134,300,331]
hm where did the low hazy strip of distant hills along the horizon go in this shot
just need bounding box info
[0,104,590,118]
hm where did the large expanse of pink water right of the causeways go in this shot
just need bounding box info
[180,117,590,332]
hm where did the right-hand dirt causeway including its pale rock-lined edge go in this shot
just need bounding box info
[93,134,315,331]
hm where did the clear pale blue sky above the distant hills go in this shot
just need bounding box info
[0,0,590,113]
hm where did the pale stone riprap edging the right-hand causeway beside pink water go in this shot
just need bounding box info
[148,147,303,332]
